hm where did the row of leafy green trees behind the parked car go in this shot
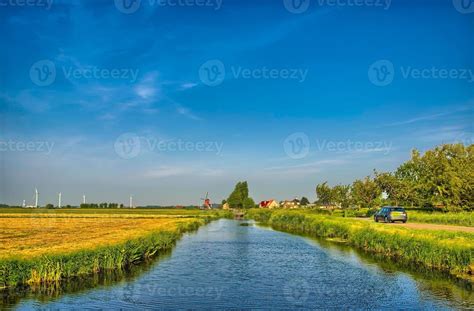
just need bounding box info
[316,144,474,210]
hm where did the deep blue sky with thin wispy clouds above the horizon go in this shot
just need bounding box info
[0,0,474,205]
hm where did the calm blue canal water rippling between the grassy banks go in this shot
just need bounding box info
[4,220,474,310]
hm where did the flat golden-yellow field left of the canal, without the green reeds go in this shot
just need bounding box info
[0,214,192,259]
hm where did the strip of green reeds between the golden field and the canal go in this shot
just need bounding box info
[0,217,209,288]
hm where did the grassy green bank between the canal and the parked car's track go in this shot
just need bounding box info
[247,209,474,282]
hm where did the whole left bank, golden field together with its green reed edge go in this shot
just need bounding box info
[0,210,230,288]
